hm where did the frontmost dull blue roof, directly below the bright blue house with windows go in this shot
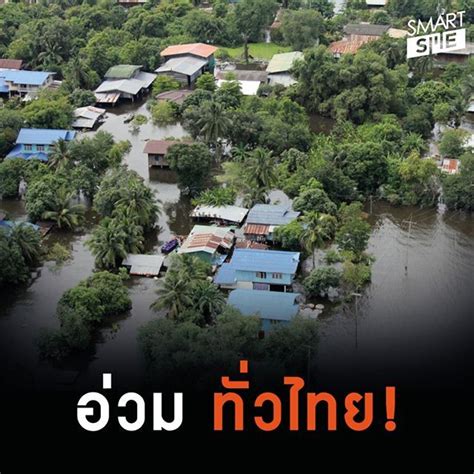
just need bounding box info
[228,290,299,321]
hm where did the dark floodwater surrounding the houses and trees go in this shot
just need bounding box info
[0,98,474,388]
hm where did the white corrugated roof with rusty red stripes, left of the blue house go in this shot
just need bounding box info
[178,225,234,254]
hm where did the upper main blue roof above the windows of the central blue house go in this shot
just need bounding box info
[226,249,300,275]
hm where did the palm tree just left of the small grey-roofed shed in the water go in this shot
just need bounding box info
[86,217,128,269]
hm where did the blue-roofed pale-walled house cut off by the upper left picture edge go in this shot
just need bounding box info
[0,69,55,97]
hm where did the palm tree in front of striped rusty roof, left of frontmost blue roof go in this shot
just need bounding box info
[151,271,192,319]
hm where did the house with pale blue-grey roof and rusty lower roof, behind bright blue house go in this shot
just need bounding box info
[244,204,300,242]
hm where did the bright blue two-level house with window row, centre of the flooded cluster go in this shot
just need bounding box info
[214,249,300,291]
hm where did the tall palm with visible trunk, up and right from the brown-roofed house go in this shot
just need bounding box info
[197,100,232,161]
